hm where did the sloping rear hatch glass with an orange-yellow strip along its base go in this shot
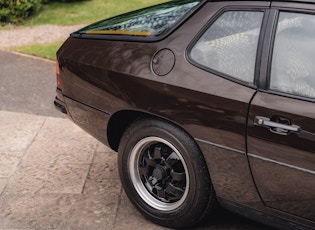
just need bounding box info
[72,0,200,38]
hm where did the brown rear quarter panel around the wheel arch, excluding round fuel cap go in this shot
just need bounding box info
[58,2,264,203]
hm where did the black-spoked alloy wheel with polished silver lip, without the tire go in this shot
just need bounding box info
[129,137,189,211]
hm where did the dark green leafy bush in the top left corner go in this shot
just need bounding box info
[0,0,43,23]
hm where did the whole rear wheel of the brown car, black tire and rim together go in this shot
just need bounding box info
[118,119,217,228]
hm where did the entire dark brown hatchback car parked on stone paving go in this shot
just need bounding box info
[55,0,315,229]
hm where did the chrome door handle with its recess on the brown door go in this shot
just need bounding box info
[254,116,301,135]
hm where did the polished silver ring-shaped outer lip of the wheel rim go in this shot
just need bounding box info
[128,136,189,211]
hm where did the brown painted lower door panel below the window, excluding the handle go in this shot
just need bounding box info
[248,93,315,220]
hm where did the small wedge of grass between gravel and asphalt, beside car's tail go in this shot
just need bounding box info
[11,42,62,60]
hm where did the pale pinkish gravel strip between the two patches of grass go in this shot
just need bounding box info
[0,25,84,49]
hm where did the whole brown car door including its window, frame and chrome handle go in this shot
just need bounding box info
[247,3,315,221]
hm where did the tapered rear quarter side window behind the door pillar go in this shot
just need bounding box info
[190,11,264,83]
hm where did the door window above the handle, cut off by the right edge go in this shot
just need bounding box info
[270,12,315,98]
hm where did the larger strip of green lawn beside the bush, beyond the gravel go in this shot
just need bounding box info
[24,0,167,26]
